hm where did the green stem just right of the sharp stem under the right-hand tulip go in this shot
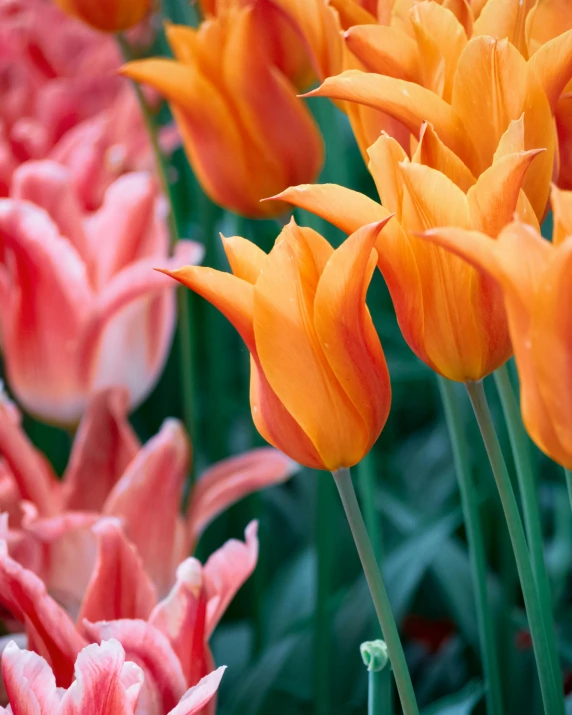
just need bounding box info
[495,365,560,685]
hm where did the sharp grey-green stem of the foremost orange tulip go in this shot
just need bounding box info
[333,468,419,715]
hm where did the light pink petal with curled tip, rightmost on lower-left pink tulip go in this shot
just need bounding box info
[203,521,258,639]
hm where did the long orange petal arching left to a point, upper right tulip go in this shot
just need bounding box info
[307,70,476,166]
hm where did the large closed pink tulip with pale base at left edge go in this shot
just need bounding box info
[0,161,202,424]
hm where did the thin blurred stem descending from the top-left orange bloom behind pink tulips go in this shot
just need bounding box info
[116,34,196,458]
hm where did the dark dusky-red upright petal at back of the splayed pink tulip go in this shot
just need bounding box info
[64,388,140,511]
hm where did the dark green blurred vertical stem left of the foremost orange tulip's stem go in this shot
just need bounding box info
[314,474,335,715]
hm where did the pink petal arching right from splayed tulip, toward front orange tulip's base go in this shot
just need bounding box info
[187,447,298,544]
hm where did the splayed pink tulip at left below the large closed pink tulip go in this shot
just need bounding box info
[0,388,294,613]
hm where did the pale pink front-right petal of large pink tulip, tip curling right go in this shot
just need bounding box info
[81,241,203,407]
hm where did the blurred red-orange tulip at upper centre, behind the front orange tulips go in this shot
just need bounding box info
[122,3,323,217]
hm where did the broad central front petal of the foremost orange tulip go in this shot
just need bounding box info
[254,224,368,470]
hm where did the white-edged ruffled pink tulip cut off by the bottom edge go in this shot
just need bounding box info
[0,639,224,715]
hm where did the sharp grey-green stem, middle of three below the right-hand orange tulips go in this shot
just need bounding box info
[466,381,564,715]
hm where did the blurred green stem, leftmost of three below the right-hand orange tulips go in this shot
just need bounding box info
[438,376,503,715]
